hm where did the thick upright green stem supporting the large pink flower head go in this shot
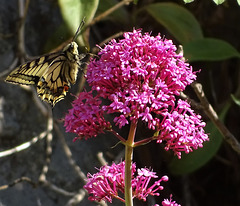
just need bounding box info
[125,122,137,206]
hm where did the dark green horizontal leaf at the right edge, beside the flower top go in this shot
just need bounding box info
[183,38,240,61]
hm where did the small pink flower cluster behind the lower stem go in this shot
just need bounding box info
[84,162,168,202]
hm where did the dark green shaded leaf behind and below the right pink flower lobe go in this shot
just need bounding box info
[169,103,230,175]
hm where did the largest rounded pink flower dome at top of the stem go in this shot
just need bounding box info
[86,30,196,129]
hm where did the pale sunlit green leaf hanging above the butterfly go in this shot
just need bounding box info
[58,0,99,34]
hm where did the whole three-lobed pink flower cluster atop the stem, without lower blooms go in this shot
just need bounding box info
[65,30,208,158]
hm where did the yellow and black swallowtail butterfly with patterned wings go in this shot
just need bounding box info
[6,41,85,106]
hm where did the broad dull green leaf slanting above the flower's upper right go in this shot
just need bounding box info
[146,3,203,44]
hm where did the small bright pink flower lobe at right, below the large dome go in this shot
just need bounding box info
[157,100,208,159]
